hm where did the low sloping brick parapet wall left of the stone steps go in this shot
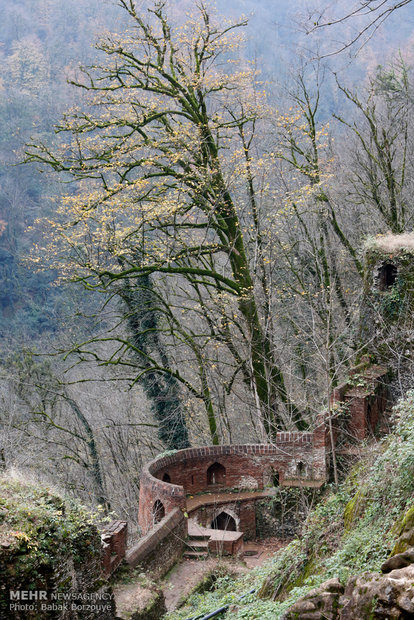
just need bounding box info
[125,508,187,579]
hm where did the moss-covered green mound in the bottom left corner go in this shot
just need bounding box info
[0,474,113,618]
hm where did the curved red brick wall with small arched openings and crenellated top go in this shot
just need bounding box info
[138,417,325,534]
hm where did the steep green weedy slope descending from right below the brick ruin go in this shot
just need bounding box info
[167,391,414,620]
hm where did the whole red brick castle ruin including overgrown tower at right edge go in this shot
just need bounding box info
[101,235,414,576]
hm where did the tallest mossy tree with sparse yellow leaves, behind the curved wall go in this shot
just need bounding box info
[26,0,297,443]
